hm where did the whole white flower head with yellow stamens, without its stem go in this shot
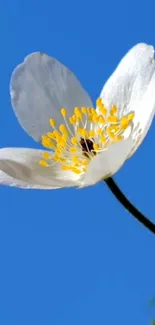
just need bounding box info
[0,44,155,189]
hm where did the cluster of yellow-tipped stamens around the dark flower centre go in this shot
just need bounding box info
[39,98,134,174]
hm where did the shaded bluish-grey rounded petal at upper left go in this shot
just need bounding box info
[10,52,92,142]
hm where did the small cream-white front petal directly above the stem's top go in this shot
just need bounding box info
[81,138,132,187]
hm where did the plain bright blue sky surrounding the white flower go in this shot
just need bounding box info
[0,0,155,325]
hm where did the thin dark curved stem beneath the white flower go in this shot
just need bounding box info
[105,177,155,234]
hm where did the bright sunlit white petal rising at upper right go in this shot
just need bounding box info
[98,44,155,156]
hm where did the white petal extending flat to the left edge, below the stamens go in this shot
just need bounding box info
[0,148,78,189]
